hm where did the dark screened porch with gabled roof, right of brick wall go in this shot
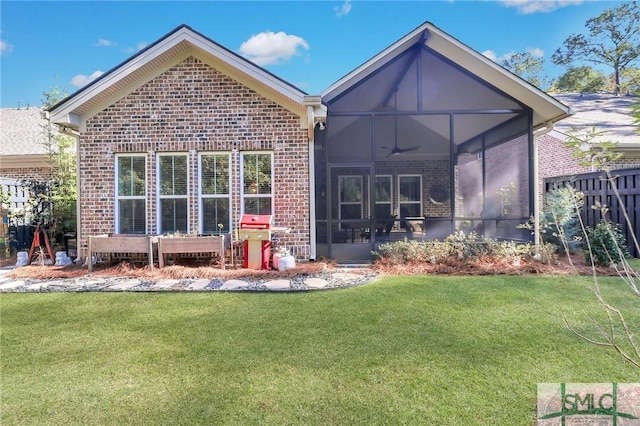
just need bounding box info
[314,23,569,261]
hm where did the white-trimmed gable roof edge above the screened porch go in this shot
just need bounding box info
[321,22,572,128]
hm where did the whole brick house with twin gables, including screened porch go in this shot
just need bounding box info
[50,23,570,260]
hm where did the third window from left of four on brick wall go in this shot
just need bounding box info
[198,153,231,234]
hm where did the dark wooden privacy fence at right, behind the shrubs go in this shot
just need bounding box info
[544,168,640,257]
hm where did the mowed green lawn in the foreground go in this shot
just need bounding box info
[0,276,640,425]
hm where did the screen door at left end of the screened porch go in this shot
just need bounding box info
[328,165,375,262]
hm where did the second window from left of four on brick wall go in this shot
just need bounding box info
[158,154,189,234]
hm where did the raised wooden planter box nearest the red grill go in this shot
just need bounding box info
[158,234,231,269]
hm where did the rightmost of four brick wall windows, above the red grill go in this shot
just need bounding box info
[241,152,273,214]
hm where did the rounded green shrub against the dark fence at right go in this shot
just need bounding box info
[585,220,631,266]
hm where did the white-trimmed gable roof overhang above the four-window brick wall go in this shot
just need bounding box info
[49,25,307,130]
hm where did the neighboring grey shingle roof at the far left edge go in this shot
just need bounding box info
[0,108,47,156]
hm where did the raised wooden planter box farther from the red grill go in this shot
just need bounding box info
[87,234,158,272]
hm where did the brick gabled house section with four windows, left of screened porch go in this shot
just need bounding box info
[51,26,322,258]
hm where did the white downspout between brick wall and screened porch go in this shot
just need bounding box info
[304,96,327,260]
